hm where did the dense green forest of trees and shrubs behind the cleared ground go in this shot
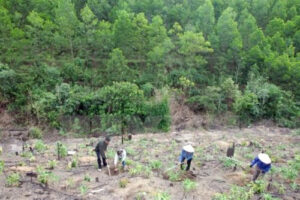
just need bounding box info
[0,0,300,132]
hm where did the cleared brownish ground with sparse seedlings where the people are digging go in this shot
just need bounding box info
[0,126,300,200]
